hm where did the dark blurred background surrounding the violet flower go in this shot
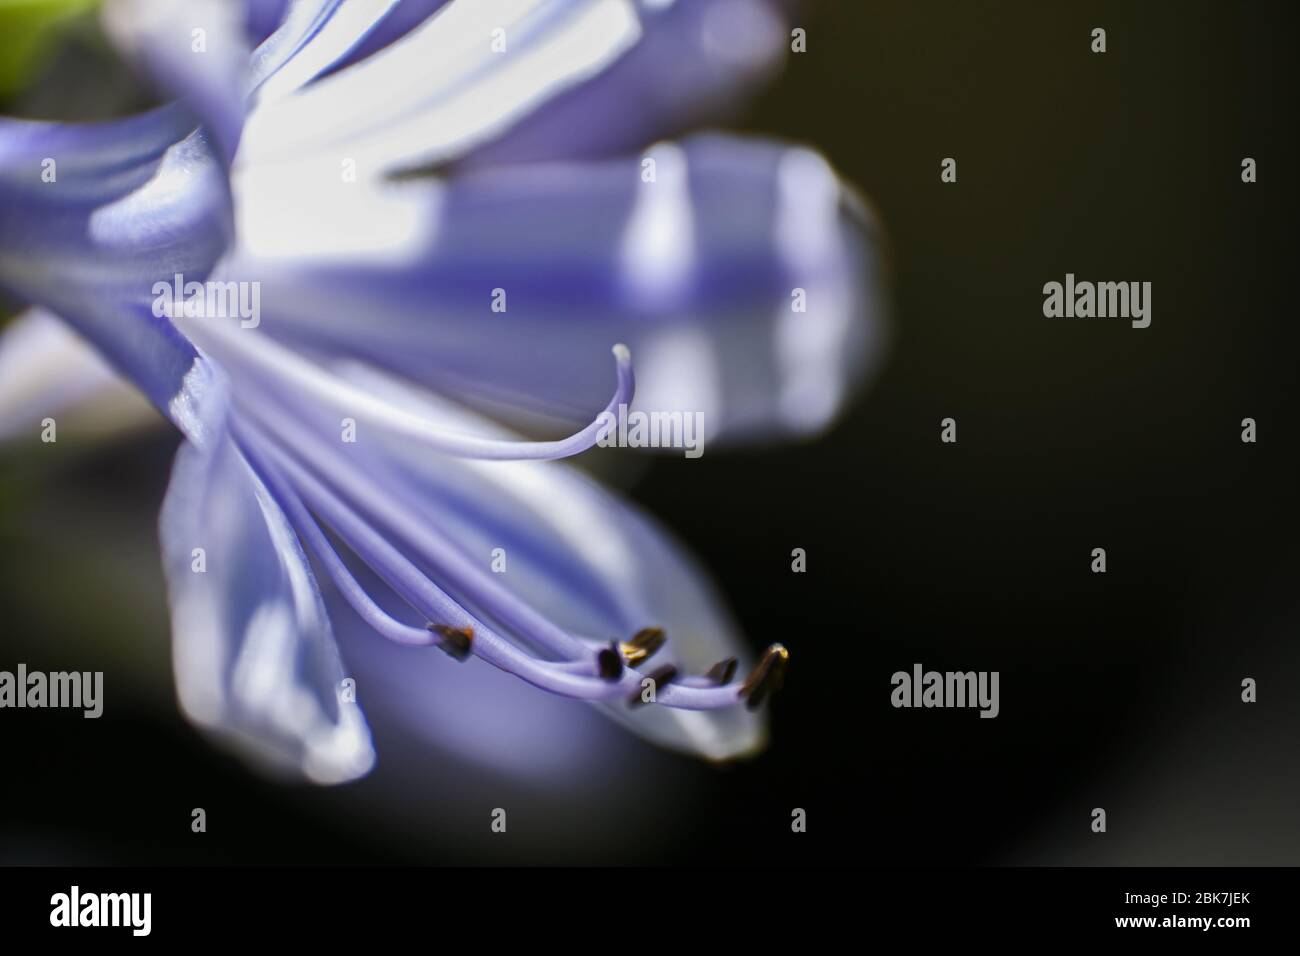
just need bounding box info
[0,0,1300,865]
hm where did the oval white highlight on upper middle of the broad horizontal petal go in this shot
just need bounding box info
[620,143,696,303]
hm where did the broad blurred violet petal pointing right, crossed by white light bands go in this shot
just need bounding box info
[221,135,883,440]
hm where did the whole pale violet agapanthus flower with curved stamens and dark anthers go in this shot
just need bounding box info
[0,0,878,782]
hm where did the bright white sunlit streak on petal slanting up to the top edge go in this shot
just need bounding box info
[242,0,641,169]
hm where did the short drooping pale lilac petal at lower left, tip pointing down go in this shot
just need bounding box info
[160,395,373,783]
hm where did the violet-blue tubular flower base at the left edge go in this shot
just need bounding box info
[0,107,231,441]
